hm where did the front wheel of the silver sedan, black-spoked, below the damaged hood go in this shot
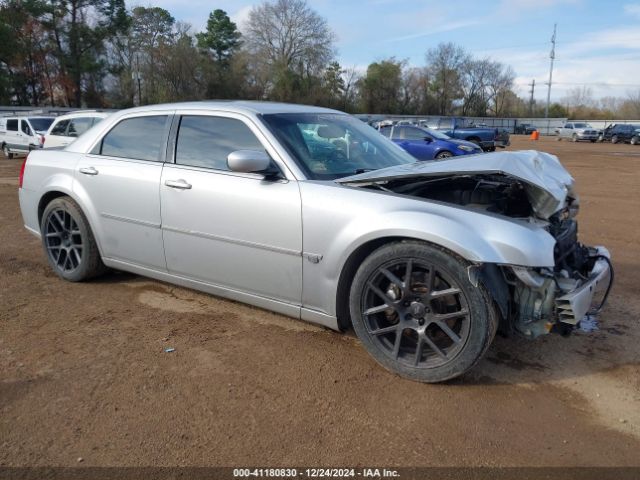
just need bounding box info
[349,241,498,383]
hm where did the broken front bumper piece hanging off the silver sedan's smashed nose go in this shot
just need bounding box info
[555,247,612,325]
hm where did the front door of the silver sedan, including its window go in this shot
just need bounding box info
[160,112,302,306]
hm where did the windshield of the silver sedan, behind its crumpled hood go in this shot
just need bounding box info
[262,113,415,180]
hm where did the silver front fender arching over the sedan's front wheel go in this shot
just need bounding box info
[301,182,555,315]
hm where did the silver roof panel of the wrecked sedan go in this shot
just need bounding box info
[119,100,342,114]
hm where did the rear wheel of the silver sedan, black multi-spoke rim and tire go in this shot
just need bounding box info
[40,197,106,282]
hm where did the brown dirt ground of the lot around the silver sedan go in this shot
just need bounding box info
[0,136,640,467]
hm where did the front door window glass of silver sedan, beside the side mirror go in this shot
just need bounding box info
[176,116,264,170]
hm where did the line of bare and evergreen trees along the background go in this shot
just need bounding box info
[0,0,640,118]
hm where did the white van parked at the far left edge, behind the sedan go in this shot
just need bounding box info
[0,116,55,158]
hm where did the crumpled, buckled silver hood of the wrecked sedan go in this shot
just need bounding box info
[336,150,575,219]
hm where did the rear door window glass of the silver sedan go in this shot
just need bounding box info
[97,115,167,162]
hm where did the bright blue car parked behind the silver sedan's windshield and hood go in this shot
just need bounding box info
[380,125,482,160]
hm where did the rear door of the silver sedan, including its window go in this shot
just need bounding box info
[74,112,173,271]
